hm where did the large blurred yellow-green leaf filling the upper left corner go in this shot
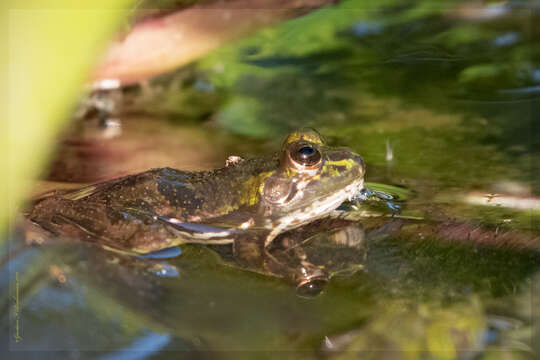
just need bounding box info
[0,0,130,240]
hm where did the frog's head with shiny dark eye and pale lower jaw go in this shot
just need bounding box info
[260,129,365,238]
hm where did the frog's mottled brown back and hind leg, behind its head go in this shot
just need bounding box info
[29,159,275,253]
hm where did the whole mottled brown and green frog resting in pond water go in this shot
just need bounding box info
[28,129,365,292]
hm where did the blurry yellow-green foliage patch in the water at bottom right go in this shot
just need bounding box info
[332,297,486,360]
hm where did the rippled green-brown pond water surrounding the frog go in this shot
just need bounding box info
[0,0,540,359]
